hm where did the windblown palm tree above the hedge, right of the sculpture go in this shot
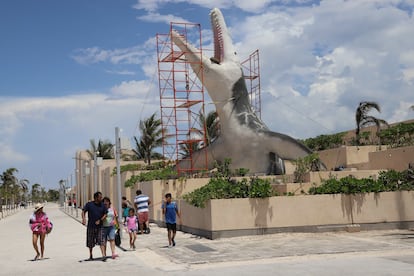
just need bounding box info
[355,102,388,146]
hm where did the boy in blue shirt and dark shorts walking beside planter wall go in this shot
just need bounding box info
[162,193,181,248]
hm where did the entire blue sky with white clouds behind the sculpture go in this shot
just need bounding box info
[0,0,414,189]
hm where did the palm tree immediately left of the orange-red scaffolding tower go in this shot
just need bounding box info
[134,113,163,165]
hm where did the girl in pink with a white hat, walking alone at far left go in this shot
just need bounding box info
[29,203,52,261]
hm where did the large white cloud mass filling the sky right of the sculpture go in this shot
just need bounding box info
[224,0,414,137]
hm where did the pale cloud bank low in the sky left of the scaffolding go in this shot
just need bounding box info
[0,91,159,188]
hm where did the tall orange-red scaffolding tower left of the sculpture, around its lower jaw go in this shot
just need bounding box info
[157,23,207,175]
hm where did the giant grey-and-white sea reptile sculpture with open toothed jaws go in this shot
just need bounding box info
[171,8,311,174]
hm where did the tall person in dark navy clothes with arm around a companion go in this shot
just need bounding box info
[82,192,108,260]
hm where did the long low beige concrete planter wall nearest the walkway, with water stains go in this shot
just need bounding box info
[175,191,414,239]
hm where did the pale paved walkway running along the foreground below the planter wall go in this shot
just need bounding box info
[0,204,414,275]
